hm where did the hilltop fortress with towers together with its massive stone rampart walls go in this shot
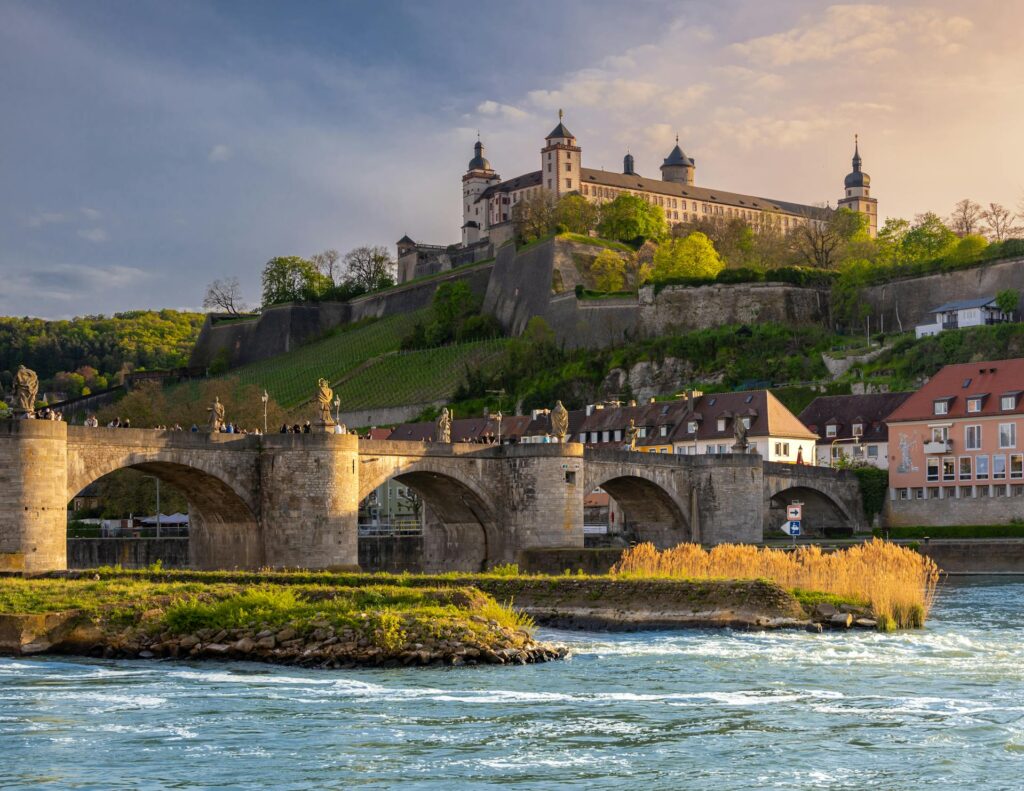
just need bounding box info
[189,120,1024,375]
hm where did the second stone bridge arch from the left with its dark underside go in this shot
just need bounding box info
[359,456,503,573]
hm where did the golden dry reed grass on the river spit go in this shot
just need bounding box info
[611,539,940,630]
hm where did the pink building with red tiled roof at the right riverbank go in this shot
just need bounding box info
[886,359,1024,525]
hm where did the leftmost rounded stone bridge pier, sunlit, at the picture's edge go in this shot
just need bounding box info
[0,420,68,574]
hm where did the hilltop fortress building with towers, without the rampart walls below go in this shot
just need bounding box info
[397,112,879,283]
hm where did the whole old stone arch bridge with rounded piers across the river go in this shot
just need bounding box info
[0,420,863,573]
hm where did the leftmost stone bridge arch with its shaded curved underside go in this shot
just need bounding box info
[65,446,266,569]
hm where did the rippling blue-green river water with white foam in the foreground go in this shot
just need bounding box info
[0,578,1024,791]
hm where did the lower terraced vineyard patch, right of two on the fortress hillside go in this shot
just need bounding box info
[335,339,508,411]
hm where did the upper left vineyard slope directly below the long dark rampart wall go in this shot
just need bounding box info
[220,310,426,409]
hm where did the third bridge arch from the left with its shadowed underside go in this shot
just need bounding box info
[587,470,694,549]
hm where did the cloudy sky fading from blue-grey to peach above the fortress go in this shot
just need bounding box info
[0,0,1024,317]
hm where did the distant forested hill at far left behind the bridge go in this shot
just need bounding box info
[0,310,205,396]
